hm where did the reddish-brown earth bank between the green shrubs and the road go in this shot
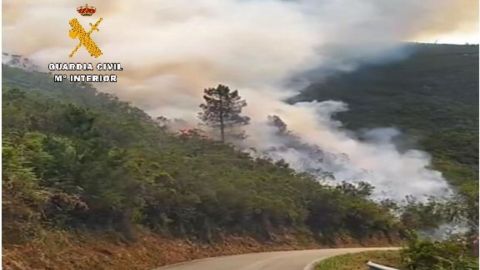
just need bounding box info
[3,231,400,270]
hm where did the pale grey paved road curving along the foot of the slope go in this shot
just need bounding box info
[156,248,395,270]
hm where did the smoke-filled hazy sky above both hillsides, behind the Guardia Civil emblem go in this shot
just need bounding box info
[2,0,478,118]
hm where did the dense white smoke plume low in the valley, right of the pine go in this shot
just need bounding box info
[247,101,451,201]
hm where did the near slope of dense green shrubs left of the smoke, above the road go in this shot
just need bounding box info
[2,66,398,246]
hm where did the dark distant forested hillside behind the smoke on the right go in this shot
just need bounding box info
[291,44,479,202]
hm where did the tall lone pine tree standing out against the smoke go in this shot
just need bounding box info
[198,84,250,142]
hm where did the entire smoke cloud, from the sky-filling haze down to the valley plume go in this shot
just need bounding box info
[3,0,477,199]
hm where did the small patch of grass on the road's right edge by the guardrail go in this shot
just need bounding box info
[315,251,400,270]
